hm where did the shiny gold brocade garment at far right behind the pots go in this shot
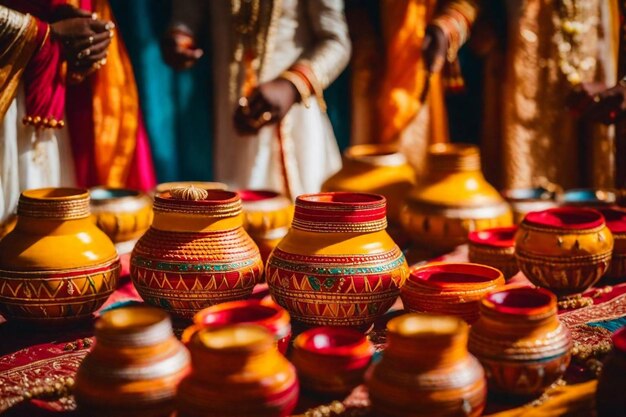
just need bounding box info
[492,0,614,188]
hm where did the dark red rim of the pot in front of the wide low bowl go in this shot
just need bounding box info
[482,287,557,316]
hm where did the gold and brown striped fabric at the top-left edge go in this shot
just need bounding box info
[0,6,37,119]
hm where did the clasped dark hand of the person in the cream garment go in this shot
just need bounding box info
[234,78,300,134]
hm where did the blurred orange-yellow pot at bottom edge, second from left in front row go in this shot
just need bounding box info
[178,324,299,417]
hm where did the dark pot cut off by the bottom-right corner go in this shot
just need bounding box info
[596,327,626,417]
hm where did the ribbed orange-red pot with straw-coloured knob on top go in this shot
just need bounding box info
[130,187,263,318]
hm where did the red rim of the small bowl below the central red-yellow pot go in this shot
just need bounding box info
[293,326,372,357]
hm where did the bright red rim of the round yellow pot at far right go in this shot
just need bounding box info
[522,207,605,230]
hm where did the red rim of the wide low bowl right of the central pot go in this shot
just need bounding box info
[409,262,504,290]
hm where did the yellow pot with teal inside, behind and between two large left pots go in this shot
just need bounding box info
[89,187,152,243]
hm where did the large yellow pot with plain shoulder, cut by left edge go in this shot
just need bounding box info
[0,188,120,324]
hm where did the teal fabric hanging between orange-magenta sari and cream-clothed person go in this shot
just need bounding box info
[111,0,213,182]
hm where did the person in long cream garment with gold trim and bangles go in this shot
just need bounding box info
[163,0,350,198]
